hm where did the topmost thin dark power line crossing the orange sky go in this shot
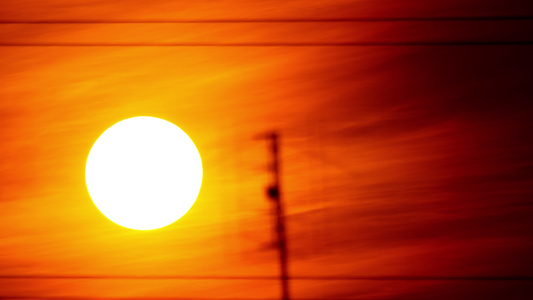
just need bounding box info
[0,16,533,24]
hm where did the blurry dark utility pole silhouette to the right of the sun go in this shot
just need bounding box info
[263,132,289,300]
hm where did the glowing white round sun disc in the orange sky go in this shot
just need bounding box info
[85,117,202,230]
